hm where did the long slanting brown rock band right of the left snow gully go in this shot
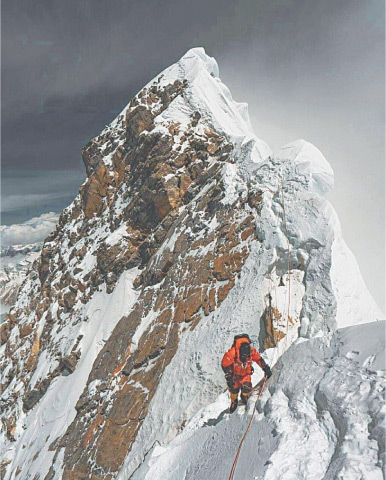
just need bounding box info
[54,199,254,478]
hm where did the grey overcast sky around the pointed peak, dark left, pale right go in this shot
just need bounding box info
[1,0,385,309]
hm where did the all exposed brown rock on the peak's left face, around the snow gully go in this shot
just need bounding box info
[3,64,259,479]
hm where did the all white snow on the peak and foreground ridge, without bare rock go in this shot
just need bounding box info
[0,48,386,480]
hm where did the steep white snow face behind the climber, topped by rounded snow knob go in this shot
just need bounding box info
[119,141,382,479]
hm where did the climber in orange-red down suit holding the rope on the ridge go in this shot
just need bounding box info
[221,333,272,413]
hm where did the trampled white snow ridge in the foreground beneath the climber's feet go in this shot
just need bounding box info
[131,321,386,480]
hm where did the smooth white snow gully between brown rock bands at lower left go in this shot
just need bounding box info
[3,269,138,478]
